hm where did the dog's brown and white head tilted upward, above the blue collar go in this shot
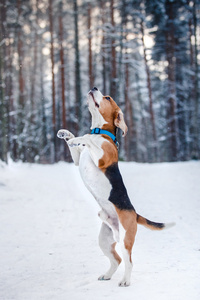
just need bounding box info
[87,87,128,136]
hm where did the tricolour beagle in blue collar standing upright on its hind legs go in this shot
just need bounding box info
[57,87,173,286]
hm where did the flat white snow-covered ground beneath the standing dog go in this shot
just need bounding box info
[0,162,200,300]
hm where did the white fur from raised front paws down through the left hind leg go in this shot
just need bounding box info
[59,130,119,280]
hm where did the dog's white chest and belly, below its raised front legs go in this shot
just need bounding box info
[79,147,115,210]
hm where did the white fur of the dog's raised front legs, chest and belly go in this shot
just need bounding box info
[58,129,118,227]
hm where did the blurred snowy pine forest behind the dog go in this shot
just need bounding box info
[0,0,200,164]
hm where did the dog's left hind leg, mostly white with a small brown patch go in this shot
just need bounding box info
[98,223,121,280]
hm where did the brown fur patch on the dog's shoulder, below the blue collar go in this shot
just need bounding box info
[99,139,118,172]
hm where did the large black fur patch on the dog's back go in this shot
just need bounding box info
[105,163,135,211]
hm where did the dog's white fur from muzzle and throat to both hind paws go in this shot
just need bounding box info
[58,90,132,286]
